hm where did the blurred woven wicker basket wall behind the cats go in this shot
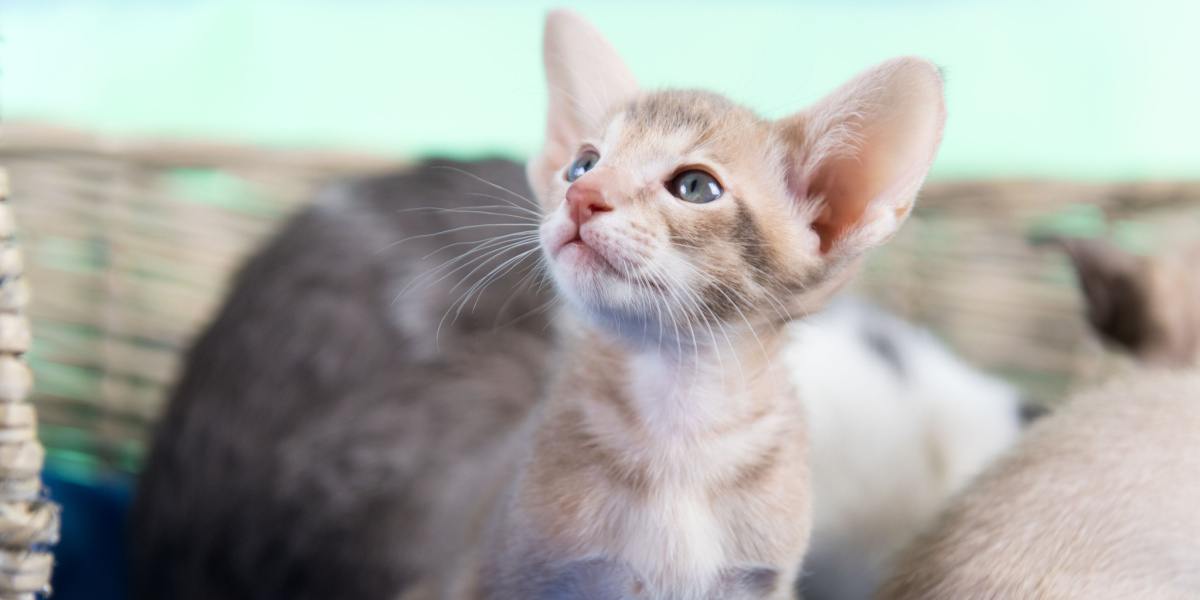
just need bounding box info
[0,124,1200,470]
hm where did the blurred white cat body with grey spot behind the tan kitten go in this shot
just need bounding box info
[784,300,1022,600]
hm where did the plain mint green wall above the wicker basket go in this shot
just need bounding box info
[0,0,1200,179]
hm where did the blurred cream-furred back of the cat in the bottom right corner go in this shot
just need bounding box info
[882,372,1200,600]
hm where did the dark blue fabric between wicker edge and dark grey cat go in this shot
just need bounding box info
[43,468,133,600]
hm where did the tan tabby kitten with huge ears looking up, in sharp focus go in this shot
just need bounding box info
[413,12,944,600]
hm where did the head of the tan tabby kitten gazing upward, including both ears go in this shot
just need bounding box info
[529,12,944,348]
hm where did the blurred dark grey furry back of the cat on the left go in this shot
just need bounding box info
[133,161,550,599]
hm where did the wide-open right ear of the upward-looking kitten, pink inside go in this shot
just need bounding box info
[776,58,946,257]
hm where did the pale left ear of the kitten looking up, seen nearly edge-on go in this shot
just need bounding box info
[528,10,637,198]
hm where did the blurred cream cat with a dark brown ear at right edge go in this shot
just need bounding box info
[881,240,1200,600]
